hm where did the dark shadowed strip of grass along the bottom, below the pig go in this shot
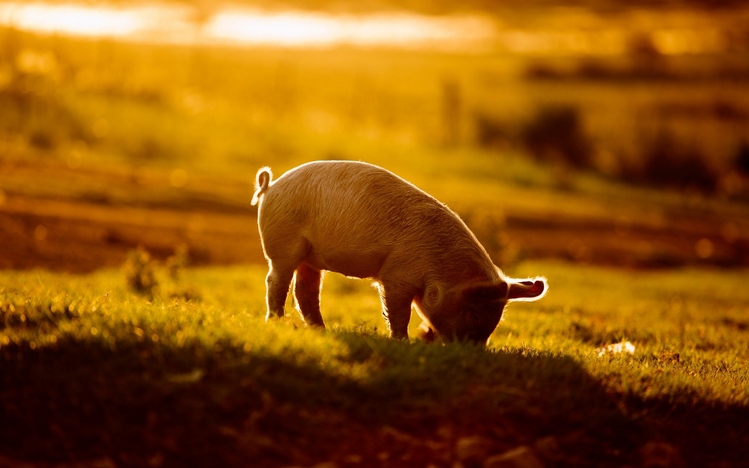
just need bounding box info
[0,332,749,466]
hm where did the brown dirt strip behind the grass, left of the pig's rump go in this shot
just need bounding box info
[0,197,264,272]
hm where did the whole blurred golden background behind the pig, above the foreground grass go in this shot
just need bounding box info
[0,0,749,272]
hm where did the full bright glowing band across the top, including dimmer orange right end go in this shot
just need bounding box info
[0,1,727,55]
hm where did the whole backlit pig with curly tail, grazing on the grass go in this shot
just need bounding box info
[252,161,547,345]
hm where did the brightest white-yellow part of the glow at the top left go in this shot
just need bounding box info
[0,3,494,50]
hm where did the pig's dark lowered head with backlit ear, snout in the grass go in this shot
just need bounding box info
[420,278,547,345]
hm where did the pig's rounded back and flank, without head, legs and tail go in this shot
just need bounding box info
[260,161,493,277]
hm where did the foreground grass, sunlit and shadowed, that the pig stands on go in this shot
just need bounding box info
[0,264,749,466]
